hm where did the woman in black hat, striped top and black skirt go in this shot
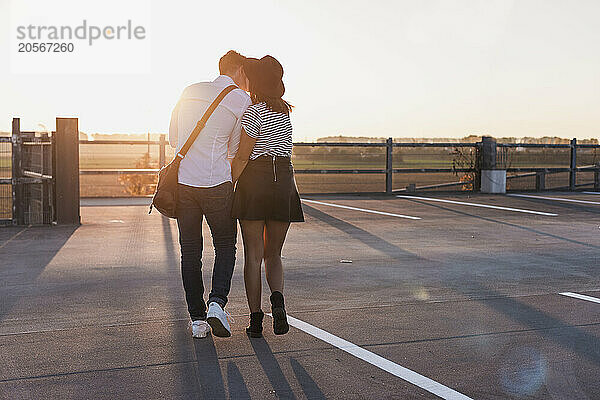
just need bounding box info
[232,56,304,337]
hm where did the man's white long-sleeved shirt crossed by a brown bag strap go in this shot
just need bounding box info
[169,75,252,187]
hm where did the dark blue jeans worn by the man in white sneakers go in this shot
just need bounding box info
[177,182,237,320]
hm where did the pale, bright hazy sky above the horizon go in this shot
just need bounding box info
[0,0,600,141]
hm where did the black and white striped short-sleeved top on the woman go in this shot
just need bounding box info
[241,102,292,160]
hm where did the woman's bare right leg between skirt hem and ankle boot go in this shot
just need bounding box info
[264,221,290,293]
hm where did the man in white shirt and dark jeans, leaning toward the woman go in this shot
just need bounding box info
[169,50,251,338]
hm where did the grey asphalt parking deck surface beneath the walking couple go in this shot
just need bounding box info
[0,193,600,399]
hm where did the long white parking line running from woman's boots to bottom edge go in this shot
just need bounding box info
[282,314,472,400]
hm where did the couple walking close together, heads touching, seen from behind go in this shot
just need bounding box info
[169,50,304,338]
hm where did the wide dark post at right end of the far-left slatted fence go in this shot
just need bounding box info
[53,118,81,225]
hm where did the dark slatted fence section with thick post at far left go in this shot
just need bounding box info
[0,118,79,225]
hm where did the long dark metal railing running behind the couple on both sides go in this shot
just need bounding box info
[80,135,600,194]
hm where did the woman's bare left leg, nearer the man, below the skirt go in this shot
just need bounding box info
[240,220,265,312]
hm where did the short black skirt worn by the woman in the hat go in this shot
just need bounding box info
[232,156,304,222]
